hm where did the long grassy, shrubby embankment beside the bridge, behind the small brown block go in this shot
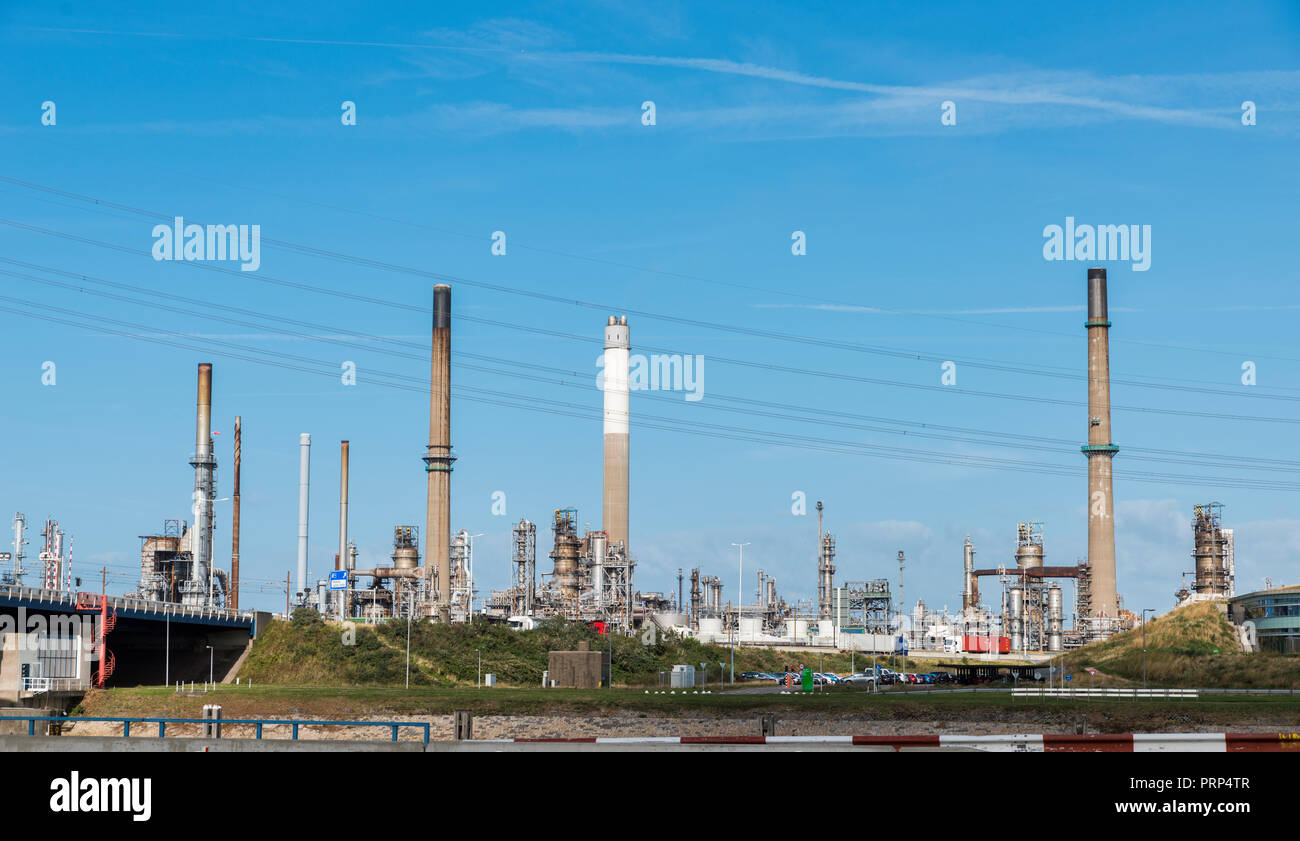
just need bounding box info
[239,611,951,688]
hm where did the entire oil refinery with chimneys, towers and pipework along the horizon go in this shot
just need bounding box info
[4,259,1263,658]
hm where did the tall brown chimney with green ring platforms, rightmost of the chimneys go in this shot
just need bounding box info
[1083,269,1119,619]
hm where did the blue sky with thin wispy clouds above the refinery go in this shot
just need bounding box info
[0,3,1300,618]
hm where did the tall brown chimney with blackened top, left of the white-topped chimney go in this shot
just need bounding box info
[424,283,456,623]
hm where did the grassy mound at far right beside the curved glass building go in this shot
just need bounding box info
[1065,602,1300,689]
